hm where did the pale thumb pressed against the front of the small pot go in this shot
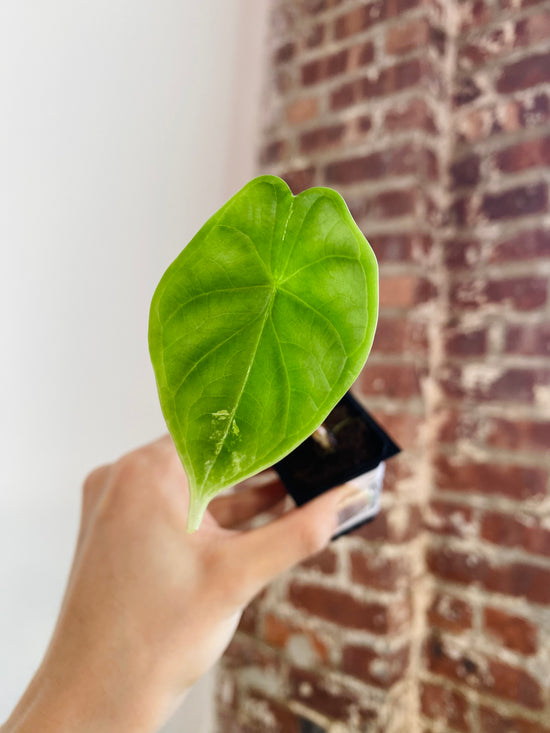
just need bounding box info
[232,483,368,603]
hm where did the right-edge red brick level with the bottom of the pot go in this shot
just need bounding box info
[481,512,550,557]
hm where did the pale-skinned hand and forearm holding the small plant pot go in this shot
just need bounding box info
[0,436,366,733]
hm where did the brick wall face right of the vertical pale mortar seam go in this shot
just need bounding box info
[421,0,550,733]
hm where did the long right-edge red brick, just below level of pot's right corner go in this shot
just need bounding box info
[434,454,548,500]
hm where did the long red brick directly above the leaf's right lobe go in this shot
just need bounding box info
[324,143,419,184]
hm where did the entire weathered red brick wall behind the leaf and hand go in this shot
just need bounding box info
[218,0,550,733]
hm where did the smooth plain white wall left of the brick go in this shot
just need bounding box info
[0,0,267,733]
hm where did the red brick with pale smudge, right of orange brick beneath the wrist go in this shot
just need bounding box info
[342,646,410,689]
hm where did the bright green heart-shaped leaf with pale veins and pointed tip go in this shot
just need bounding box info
[149,176,378,531]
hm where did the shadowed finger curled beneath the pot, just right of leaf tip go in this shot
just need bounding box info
[208,479,287,528]
